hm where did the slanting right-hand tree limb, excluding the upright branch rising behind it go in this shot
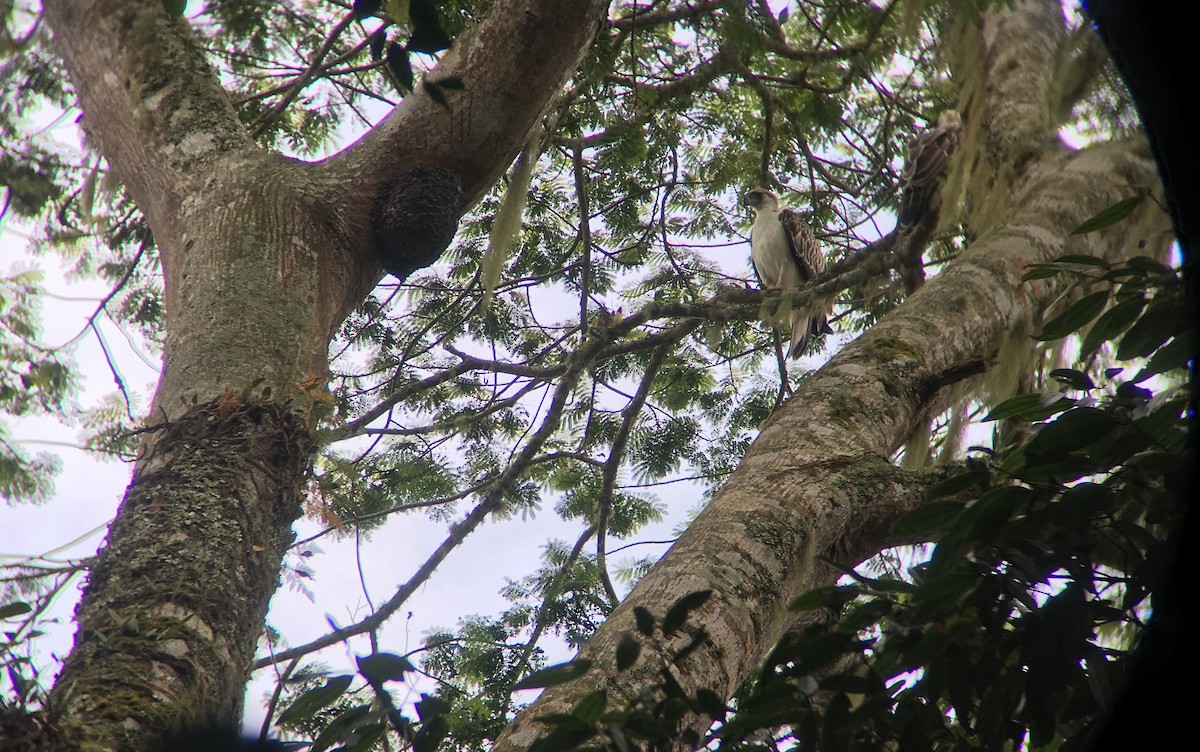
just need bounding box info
[484,135,1164,752]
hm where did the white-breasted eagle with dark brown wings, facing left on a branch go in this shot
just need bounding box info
[743,188,833,357]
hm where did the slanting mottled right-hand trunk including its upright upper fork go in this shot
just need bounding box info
[494,2,1169,752]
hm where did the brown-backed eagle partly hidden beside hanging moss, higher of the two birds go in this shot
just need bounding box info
[896,109,962,234]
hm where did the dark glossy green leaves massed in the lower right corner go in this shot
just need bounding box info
[516,250,1195,752]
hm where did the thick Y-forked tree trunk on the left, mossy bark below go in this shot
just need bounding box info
[37,0,607,750]
